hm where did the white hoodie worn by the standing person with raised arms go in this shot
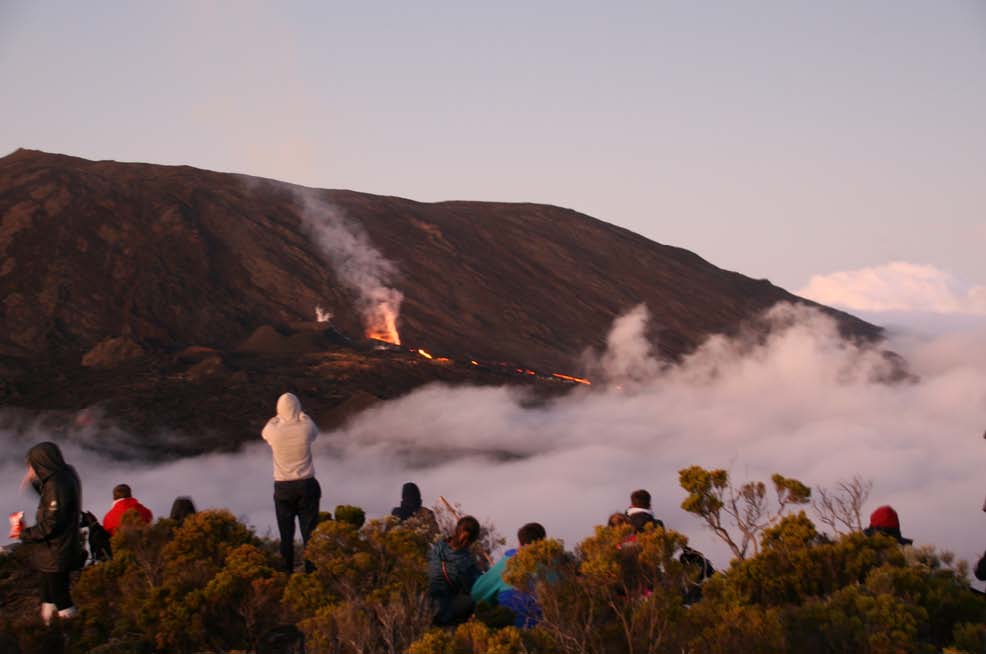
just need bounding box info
[261,393,318,481]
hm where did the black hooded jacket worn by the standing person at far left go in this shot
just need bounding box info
[21,442,85,572]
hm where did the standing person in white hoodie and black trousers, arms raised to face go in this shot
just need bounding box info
[261,393,322,574]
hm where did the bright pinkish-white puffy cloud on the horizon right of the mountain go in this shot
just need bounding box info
[798,261,986,316]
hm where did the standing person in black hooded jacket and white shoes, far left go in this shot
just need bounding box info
[20,442,86,624]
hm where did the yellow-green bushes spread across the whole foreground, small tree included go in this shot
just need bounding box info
[0,468,986,654]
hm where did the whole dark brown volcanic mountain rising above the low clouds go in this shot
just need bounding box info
[0,150,880,454]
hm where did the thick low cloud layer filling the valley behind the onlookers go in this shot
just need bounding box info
[0,306,986,584]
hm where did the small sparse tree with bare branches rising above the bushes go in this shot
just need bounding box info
[678,466,811,559]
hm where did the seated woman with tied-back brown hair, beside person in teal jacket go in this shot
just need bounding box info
[428,515,480,627]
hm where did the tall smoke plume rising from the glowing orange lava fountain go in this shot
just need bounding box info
[297,190,404,345]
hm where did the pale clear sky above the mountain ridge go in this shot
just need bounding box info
[0,0,986,290]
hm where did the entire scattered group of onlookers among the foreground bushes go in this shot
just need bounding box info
[10,393,986,627]
